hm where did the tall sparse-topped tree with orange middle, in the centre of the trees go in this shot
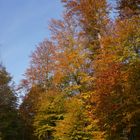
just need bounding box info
[50,14,90,94]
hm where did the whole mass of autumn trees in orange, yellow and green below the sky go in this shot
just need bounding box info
[0,0,140,140]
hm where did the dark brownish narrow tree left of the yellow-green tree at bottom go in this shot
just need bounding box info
[19,86,44,140]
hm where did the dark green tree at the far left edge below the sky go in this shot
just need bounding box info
[0,65,22,140]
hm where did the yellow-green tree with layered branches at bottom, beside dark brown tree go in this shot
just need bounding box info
[33,90,66,140]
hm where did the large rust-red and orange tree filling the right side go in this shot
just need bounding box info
[91,14,140,140]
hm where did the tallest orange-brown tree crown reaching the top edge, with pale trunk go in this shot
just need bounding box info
[62,0,109,59]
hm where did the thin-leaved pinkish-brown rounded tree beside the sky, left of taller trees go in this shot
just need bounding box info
[25,40,55,89]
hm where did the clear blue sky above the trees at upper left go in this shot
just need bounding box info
[0,0,63,84]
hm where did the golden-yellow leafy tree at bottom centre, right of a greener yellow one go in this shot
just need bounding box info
[55,96,93,140]
